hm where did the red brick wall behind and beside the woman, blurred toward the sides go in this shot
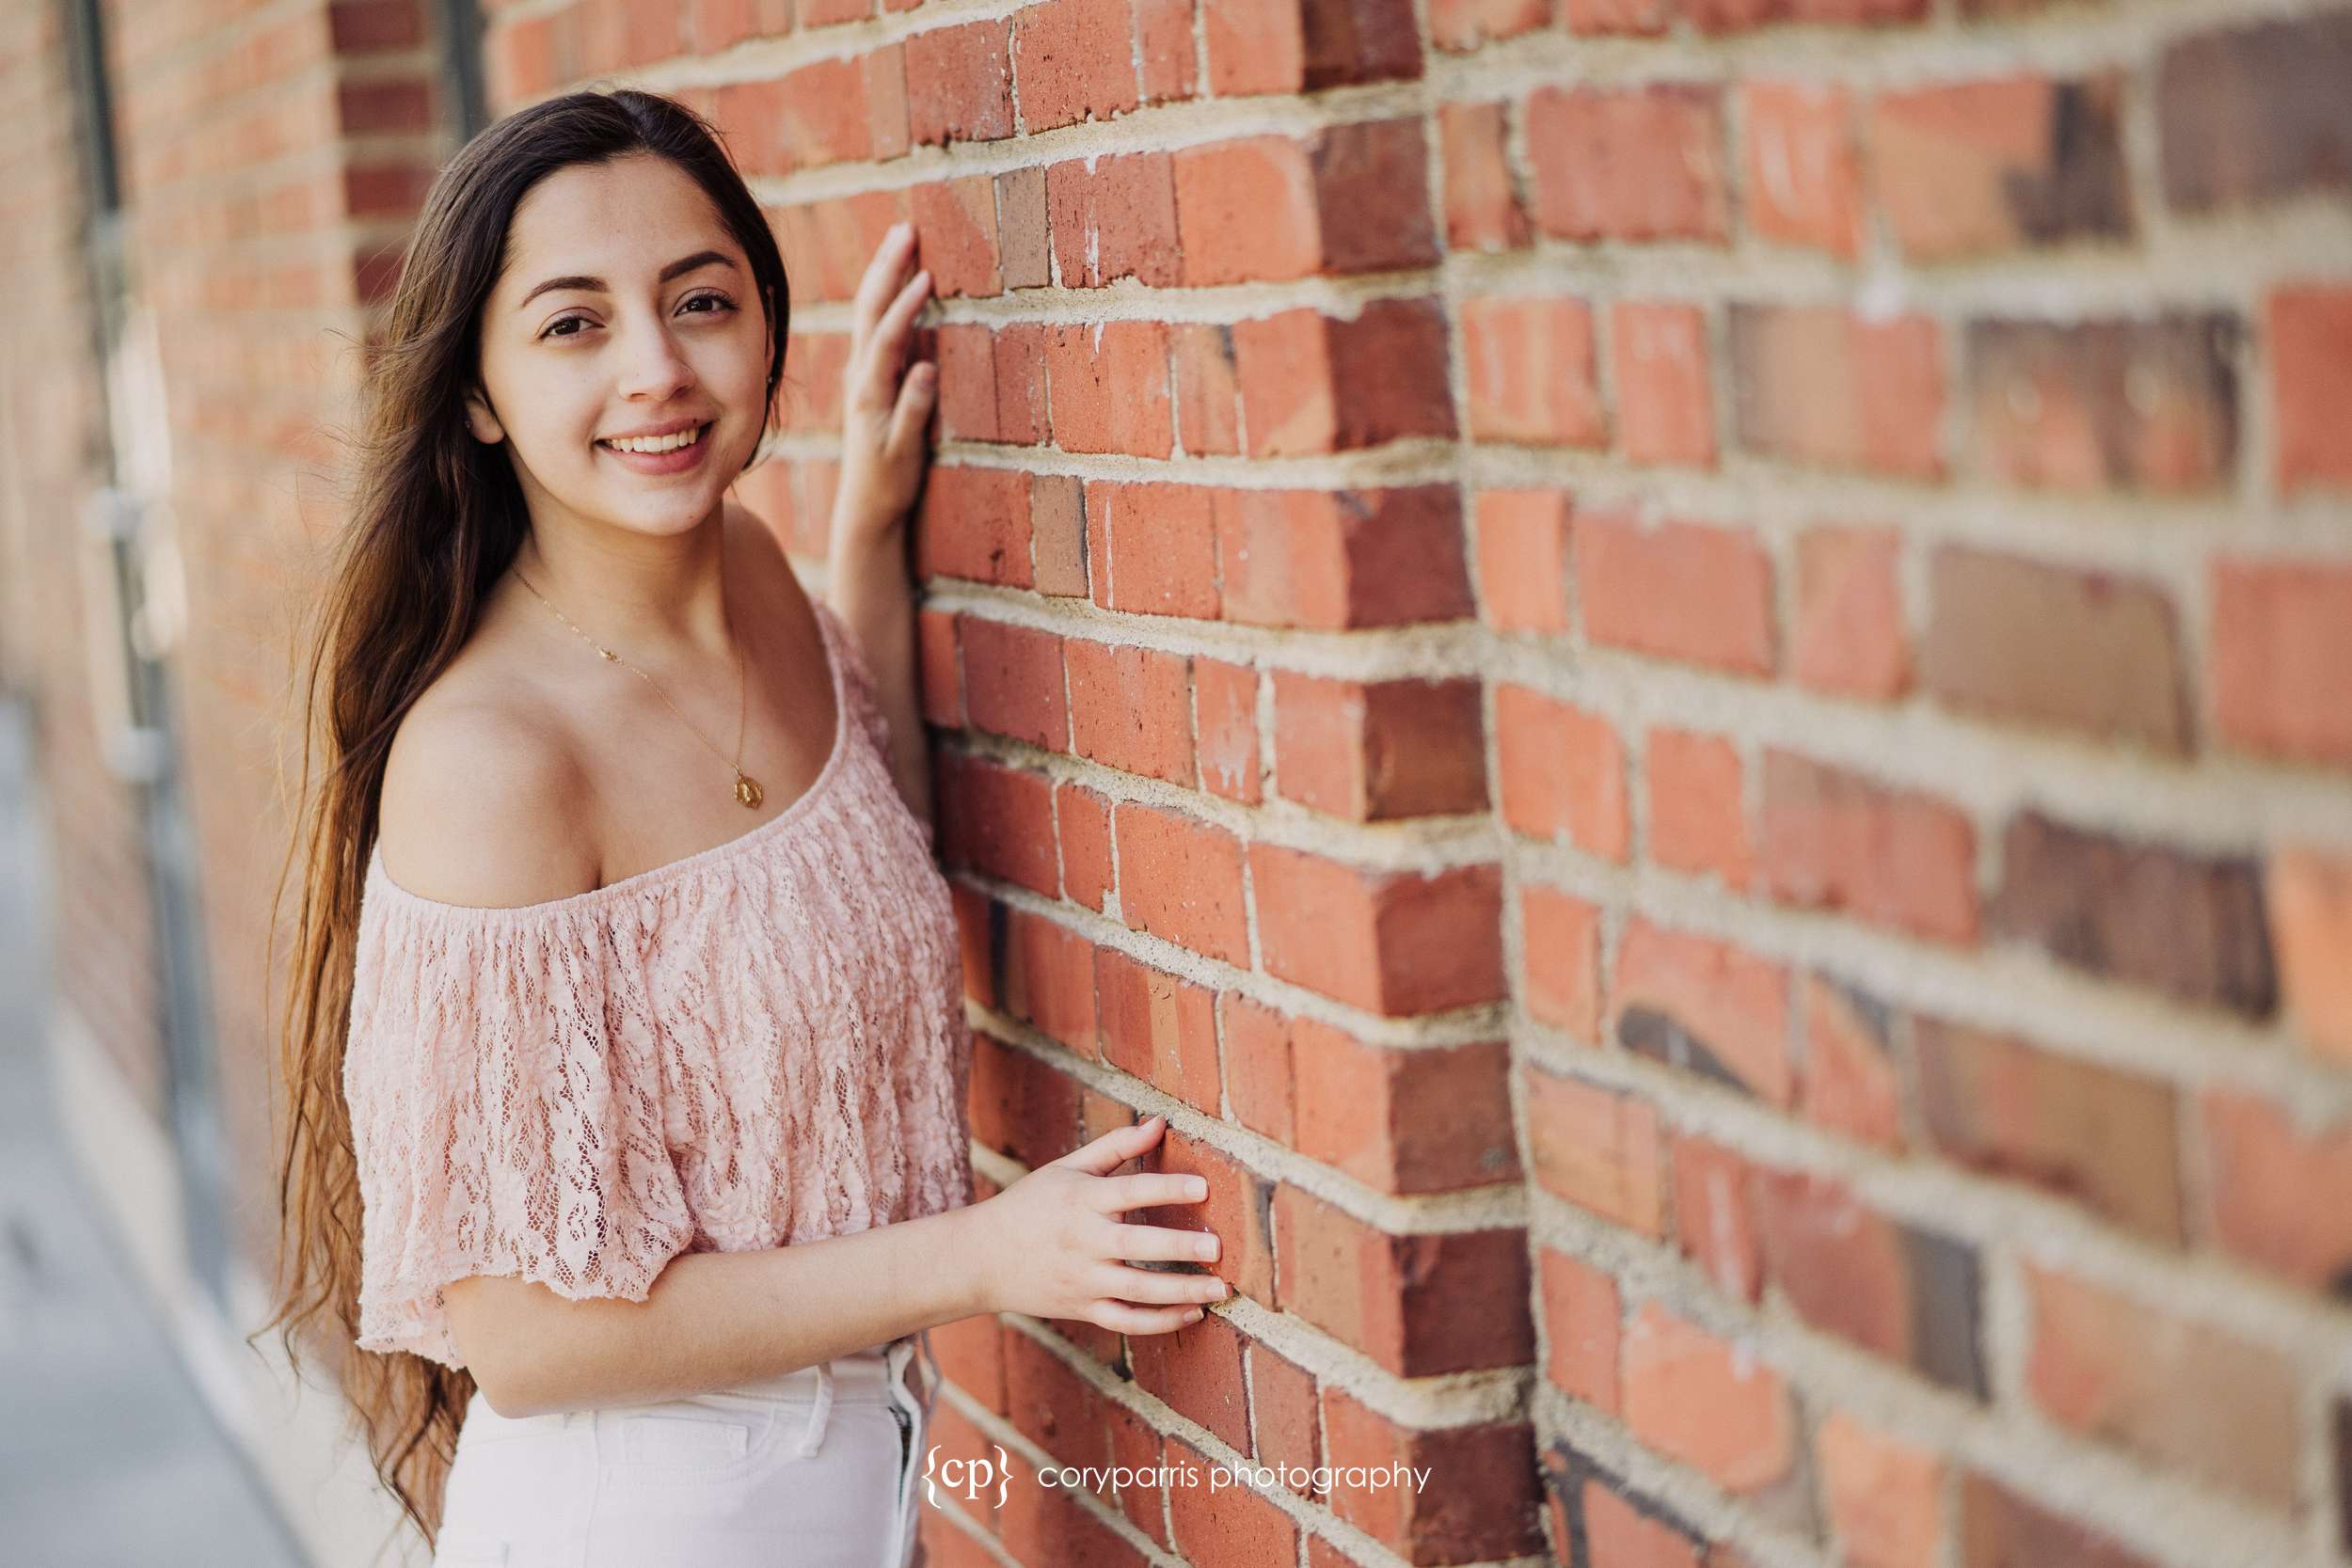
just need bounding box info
[0,0,2352,1568]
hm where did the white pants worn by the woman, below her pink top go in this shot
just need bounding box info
[433,1336,939,1568]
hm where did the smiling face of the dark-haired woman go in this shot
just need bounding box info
[466,155,770,533]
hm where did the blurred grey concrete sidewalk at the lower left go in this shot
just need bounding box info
[0,701,309,1568]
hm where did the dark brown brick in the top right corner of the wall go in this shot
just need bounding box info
[2154,11,2352,212]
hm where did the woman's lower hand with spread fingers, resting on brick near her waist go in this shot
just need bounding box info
[964,1117,1228,1336]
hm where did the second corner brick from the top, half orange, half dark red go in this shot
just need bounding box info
[1174,118,1438,287]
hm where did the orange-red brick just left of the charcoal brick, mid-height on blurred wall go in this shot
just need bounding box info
[1759,748,1979,942]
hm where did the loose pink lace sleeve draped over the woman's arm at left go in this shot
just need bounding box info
[343,879,694,1369]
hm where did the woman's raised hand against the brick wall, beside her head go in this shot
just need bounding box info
[833,223,939,541]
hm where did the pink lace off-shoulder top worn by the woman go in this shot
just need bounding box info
[343,602,972,1369]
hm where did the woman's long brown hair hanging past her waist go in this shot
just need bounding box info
[247,89,790,1544]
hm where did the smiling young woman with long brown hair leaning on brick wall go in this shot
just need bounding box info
[266,91,1226,1568]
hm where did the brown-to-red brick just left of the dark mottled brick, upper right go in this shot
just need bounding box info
[1729,303,1943,480]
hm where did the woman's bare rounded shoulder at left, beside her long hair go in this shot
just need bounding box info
[376,649,597,908]
